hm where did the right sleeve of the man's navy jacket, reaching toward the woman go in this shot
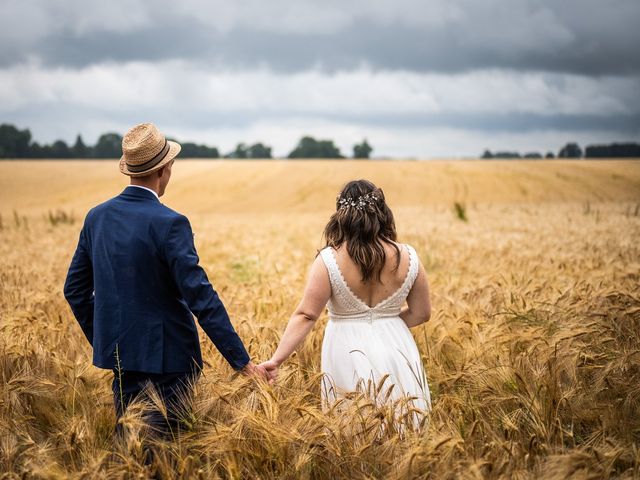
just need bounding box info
[165,215,250,370]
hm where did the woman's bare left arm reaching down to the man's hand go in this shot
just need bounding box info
[265,255,331,370]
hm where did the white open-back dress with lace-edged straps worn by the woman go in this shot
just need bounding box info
[320,245,431,411]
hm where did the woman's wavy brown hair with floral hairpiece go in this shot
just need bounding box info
[323,180,400,282]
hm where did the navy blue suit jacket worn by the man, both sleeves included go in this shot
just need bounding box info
[64,186,249,373]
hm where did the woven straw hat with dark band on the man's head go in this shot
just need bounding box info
[120,123,182,177]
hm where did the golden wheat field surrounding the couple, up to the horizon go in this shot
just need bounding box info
[0,159,640,479]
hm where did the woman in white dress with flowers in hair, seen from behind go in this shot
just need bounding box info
[263,180,431,420]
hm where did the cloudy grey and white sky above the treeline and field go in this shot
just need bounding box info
[0,0,640,158]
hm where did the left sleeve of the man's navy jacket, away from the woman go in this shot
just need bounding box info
[64,222,95,345]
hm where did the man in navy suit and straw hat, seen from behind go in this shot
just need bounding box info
[64,123,275,435]
